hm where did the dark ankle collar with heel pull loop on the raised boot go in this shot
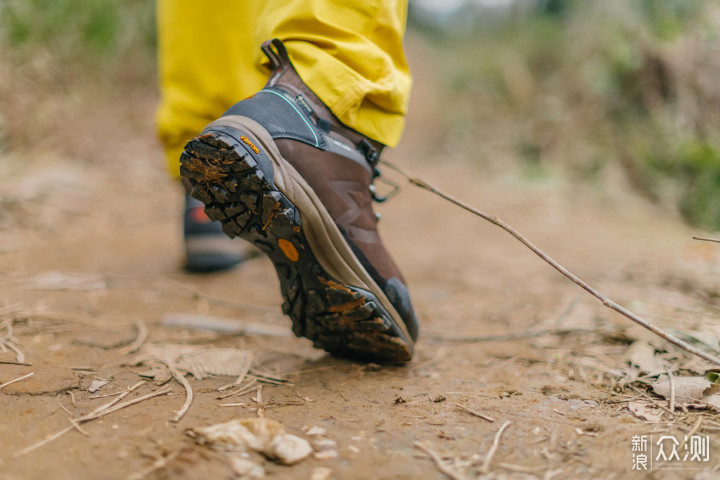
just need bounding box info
[261,38,385,169]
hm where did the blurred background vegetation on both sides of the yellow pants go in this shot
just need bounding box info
[0,0,720,230]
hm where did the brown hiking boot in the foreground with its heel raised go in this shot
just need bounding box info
[180,40,418,361]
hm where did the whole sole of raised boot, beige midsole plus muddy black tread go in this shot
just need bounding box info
[180,117,413,362]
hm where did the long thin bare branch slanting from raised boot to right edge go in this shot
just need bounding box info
[382,160,720,366]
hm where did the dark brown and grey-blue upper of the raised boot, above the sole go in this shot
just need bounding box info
[225,40,418,340]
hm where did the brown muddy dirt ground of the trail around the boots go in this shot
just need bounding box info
[0,47,720,480]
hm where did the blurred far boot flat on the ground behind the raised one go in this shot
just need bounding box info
[183,185,254,273]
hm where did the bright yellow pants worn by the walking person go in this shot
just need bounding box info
[157,0,411,175]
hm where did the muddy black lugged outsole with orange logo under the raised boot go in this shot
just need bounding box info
[180,131,412,362]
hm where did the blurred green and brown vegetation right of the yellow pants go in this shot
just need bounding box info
[411,0,720,229]
